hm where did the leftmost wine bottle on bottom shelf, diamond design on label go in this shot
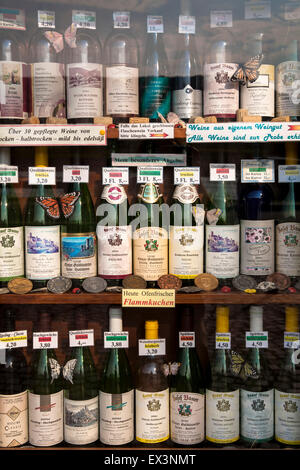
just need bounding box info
[0,310,28,447]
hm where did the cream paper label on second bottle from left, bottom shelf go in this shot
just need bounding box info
[28,390,64,447]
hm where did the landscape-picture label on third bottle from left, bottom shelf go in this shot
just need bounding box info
[64,396,99,445]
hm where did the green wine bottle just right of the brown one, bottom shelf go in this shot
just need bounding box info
[170,306,205,446]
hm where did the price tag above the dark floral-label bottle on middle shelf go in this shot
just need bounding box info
[241,160,275,183]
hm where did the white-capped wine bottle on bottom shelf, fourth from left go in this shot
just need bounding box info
[99,307,134,446]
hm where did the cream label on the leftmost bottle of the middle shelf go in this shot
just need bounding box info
[0,227,24,281]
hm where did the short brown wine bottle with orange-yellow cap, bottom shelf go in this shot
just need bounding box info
[135,321,169,444]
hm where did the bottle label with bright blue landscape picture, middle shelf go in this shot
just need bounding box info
[61,232,97,279]
